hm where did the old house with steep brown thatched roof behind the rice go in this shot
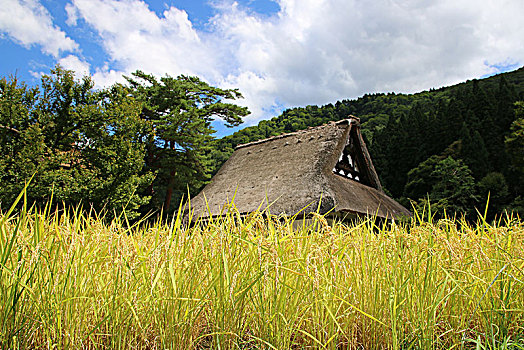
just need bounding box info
[191,116,411,220]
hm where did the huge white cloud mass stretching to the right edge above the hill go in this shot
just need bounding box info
[67,0,524,123]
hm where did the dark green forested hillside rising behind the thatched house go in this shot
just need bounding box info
[210,68,524,217]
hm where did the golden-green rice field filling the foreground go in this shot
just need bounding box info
[0,197,524,349]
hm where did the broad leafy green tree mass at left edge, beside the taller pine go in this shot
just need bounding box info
[0,66,153,217]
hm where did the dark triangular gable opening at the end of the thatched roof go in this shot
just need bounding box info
[333,116,382,191]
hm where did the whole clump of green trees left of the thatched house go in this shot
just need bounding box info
[0,66,249,218]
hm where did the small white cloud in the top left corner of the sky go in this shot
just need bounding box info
[0,0,78,57]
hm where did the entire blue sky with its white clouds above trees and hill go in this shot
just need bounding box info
[0,0,524,135]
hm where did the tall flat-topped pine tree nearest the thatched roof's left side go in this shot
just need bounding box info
[127,71,249,213]
